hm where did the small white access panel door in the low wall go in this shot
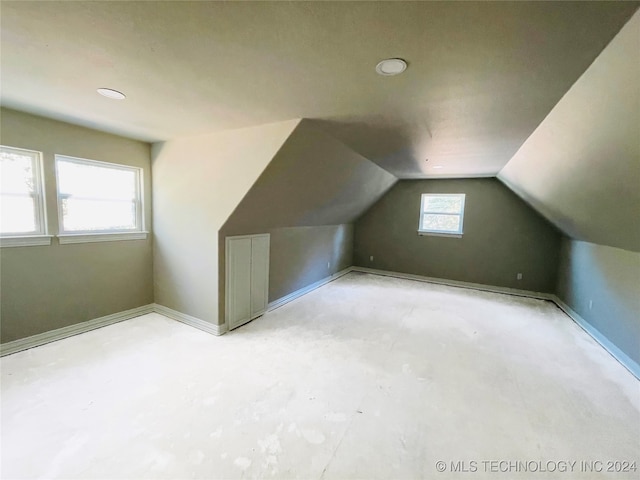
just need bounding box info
[225,234,269,330]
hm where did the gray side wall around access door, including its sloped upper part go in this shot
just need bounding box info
[218,120,396,318]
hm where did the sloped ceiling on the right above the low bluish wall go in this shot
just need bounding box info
[498,12,640,252]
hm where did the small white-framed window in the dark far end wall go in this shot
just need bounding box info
[418,193,464,236]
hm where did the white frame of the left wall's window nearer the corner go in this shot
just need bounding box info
[55,154,149,244]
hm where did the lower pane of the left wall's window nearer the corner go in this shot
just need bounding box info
[62,197,136,232]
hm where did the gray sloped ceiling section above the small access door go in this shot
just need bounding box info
[221,120,397,235]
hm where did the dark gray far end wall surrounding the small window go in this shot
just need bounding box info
[354,178,561,292]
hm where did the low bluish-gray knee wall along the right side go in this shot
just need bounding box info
[557,238,640,364]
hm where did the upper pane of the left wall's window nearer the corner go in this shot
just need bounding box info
[58,160,136,200]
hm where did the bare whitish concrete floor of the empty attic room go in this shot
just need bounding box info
[1,273,640,479]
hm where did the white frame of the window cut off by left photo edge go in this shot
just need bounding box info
[0,145,52,247]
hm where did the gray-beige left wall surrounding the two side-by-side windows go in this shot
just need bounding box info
[0,109,153,343]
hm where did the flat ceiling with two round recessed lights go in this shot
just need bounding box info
[0,1,639,178]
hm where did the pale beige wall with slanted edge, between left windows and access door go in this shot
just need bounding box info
[152,120,299,324]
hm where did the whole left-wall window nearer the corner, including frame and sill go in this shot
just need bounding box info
[56,155,146,243]
